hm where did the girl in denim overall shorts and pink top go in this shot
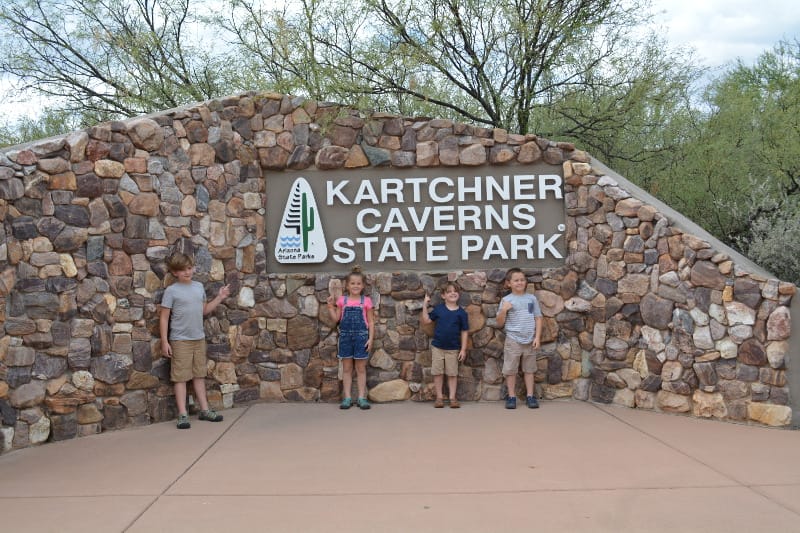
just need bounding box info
[328,269,375,409]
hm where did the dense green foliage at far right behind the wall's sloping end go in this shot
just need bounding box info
[650,40,800,281]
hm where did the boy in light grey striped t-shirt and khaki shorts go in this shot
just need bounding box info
[497,268,542,409]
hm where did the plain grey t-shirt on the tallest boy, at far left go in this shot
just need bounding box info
[161,281,206,341]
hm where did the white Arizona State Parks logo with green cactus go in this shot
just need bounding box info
[275,178,328,263]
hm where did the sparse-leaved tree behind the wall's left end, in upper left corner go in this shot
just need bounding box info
[0,0,238,121]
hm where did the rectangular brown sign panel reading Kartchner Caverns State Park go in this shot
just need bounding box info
[266,163,566,273]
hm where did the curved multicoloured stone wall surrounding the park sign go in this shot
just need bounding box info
[0,94,795,451]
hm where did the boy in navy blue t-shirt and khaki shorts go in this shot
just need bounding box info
[422,283,469,409]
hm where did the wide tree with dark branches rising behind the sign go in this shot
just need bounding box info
[218,0,698,152]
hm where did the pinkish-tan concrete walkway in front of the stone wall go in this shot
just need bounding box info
[0,401,800,533]
